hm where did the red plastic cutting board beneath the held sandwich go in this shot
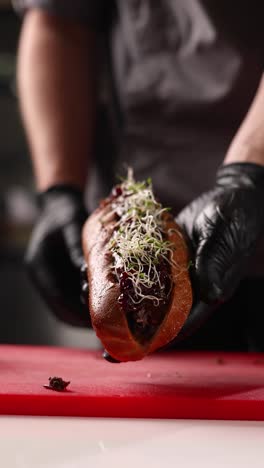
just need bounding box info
[0,345,264,420]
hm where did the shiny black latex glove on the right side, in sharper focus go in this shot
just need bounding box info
[173,163,264,338]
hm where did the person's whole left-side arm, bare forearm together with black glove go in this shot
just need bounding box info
[17,10,99,326]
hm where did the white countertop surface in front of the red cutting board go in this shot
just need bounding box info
[0,417,264,468]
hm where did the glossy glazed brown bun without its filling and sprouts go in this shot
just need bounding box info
[83,176,192,361]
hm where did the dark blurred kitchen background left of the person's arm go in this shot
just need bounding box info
[0,0,98,347]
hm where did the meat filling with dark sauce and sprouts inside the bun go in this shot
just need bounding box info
[104,177,173,344]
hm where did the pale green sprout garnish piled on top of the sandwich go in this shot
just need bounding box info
[108,169,182,306]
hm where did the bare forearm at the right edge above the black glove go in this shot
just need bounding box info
[224,78,264,165]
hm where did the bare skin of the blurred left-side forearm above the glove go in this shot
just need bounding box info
[17,9,96,190]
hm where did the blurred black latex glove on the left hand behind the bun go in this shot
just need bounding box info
[26,185,90,326]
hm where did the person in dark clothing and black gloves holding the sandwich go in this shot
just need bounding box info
[14,0,264,351]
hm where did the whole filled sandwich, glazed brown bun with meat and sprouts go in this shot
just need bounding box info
[83,170,192,362]
